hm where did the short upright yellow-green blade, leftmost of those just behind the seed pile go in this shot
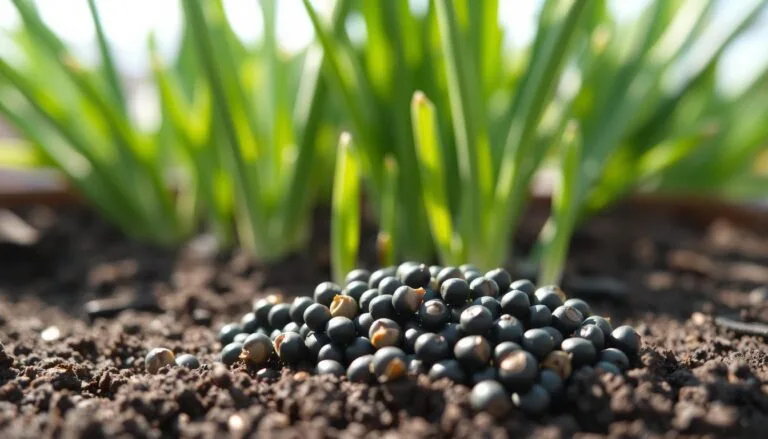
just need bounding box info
[331,133,361,282]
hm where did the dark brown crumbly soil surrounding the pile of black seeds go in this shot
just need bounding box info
[0,206,768,438]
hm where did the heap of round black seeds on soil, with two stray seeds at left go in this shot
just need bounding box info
[146,262,640,415]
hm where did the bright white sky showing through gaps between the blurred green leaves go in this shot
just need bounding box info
[0,0,768,96]
